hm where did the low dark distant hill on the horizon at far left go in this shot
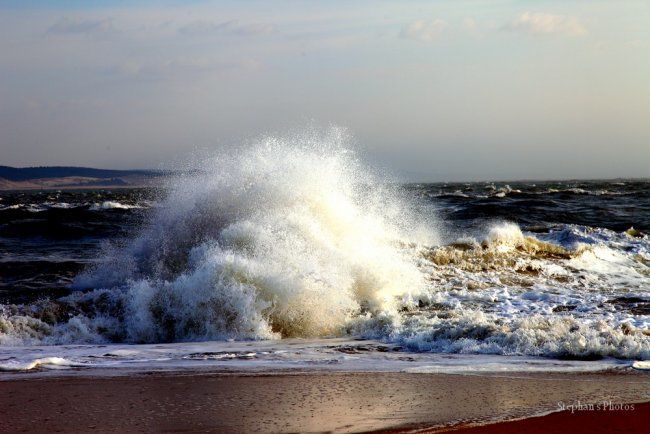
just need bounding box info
[0,166,164,190]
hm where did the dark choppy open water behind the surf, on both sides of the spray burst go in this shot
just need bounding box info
[0,180,650,303]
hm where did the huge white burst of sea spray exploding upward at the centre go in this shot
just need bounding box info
[66,129,436,342]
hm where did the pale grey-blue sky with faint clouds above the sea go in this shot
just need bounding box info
[0,0,650,181]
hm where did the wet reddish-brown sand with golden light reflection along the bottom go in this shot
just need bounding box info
[0,372,650,433]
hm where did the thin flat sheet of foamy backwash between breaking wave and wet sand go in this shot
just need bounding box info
[0,339,630,379]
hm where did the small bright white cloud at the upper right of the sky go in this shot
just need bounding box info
[504,12,587,36]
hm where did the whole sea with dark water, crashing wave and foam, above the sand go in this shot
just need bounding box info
[0,137,650,375]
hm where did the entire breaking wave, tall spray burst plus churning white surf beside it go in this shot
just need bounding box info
[0,129,650,359]
